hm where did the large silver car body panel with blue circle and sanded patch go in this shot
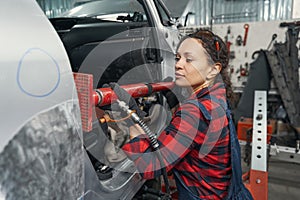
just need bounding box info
[0,0,84,200]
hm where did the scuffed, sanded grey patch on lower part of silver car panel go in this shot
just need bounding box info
[0,102,84,200]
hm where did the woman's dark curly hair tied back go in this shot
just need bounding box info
[178,29,236,105]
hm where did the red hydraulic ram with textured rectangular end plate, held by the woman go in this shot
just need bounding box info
[73,73,175,132]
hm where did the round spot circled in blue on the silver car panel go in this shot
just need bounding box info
[16,48,60,97]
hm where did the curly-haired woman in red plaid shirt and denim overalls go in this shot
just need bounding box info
[111,30,252,200]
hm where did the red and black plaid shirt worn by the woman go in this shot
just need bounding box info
[123,83,231,199]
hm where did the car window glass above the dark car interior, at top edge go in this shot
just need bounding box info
[58,0,146,22]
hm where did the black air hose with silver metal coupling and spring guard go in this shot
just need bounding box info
[117,100,170,197]
